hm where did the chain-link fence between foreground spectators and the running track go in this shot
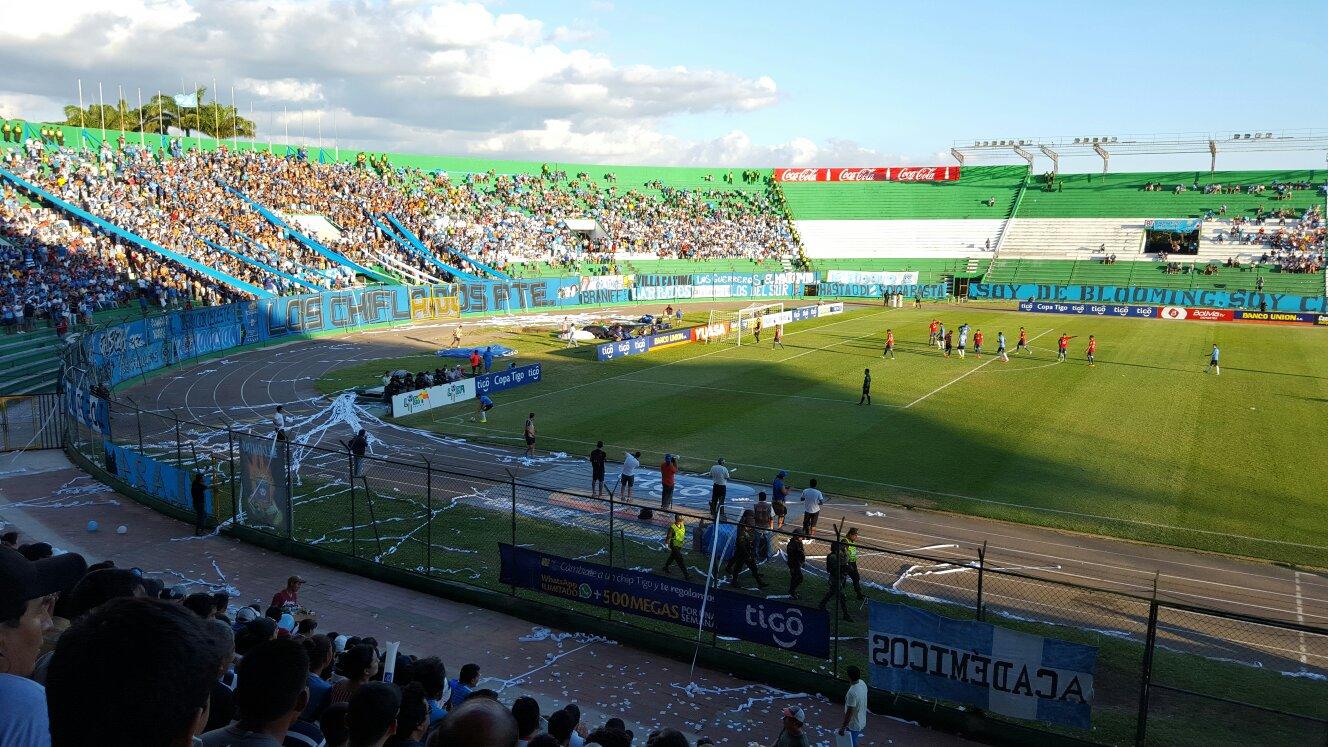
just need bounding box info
[41,393,1328,744]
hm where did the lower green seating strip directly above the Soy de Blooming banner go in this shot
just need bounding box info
[983,259,1324,296]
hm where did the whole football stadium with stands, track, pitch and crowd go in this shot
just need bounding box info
[0,5,1328,747]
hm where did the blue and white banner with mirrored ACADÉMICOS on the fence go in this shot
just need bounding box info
[867,602,1097,728]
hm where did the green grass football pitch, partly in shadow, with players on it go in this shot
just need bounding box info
[324,299,1328,566]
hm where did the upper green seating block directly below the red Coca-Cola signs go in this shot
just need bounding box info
[782,166,1028,221]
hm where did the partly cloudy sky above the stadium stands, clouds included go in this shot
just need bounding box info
[0,0,1328,171]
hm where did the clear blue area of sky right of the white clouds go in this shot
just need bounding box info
[499,0,1328,167]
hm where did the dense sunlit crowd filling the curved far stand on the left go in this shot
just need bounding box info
[0,137,795,302]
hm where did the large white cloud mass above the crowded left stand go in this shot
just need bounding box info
[0,0,882,165]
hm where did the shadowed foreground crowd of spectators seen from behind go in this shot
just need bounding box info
[0,523,759,747]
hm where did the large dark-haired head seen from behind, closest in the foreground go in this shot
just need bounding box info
[47,598,222,747]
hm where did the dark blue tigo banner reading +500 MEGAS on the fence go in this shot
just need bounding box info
[498,542,830,658]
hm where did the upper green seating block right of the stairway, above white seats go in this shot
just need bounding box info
[1015,169,1328,218]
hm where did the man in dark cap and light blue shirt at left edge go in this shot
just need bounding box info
[0,539,88,746]
